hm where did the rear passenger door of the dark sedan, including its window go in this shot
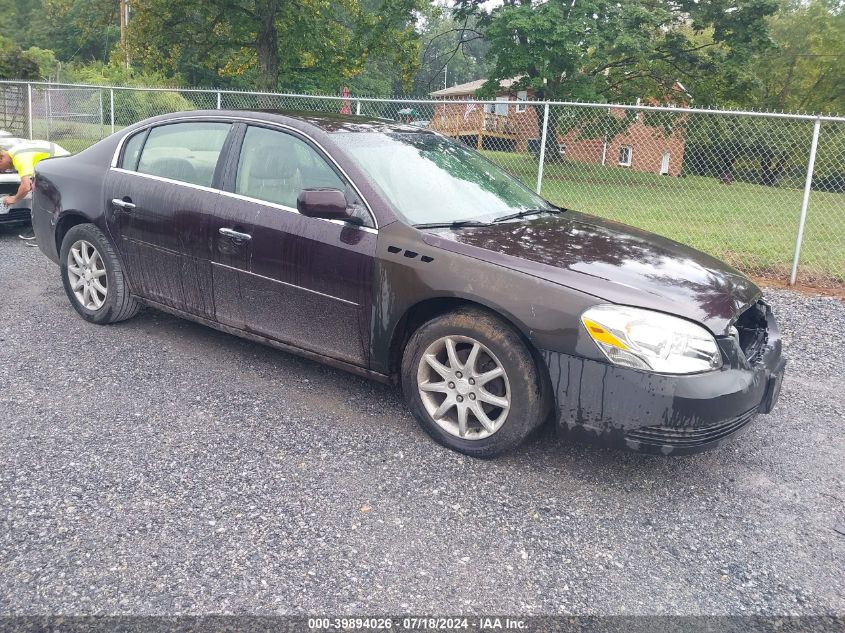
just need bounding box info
[105,121,237,319]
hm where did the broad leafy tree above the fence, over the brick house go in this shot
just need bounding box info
[456,0,777,103]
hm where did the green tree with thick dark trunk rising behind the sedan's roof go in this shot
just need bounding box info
[130,0,422,92]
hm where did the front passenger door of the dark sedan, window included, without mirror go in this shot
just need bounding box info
[212,126,376,366]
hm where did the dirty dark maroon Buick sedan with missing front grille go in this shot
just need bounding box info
[33,110,785,457]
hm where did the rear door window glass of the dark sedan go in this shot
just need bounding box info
[137,122,231,187]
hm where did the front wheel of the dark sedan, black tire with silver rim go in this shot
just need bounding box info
[402,308,549,457]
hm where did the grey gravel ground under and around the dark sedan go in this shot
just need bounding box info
[0,229,845,615]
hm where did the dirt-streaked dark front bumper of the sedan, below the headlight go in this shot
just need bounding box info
[541,306,786,455]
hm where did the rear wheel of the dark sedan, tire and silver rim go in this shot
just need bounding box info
[59,224,141,325]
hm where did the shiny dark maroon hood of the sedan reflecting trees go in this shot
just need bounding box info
[423,211,762,334]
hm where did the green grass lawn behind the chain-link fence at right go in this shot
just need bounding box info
[484,152,845,285]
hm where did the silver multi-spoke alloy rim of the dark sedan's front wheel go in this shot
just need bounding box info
[417,336,511,440]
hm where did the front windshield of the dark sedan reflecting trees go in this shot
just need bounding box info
[333,132,554,224]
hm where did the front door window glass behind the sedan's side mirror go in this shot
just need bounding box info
[235,126,350,209]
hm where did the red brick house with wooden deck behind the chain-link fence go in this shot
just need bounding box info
[430,79,685,176]
